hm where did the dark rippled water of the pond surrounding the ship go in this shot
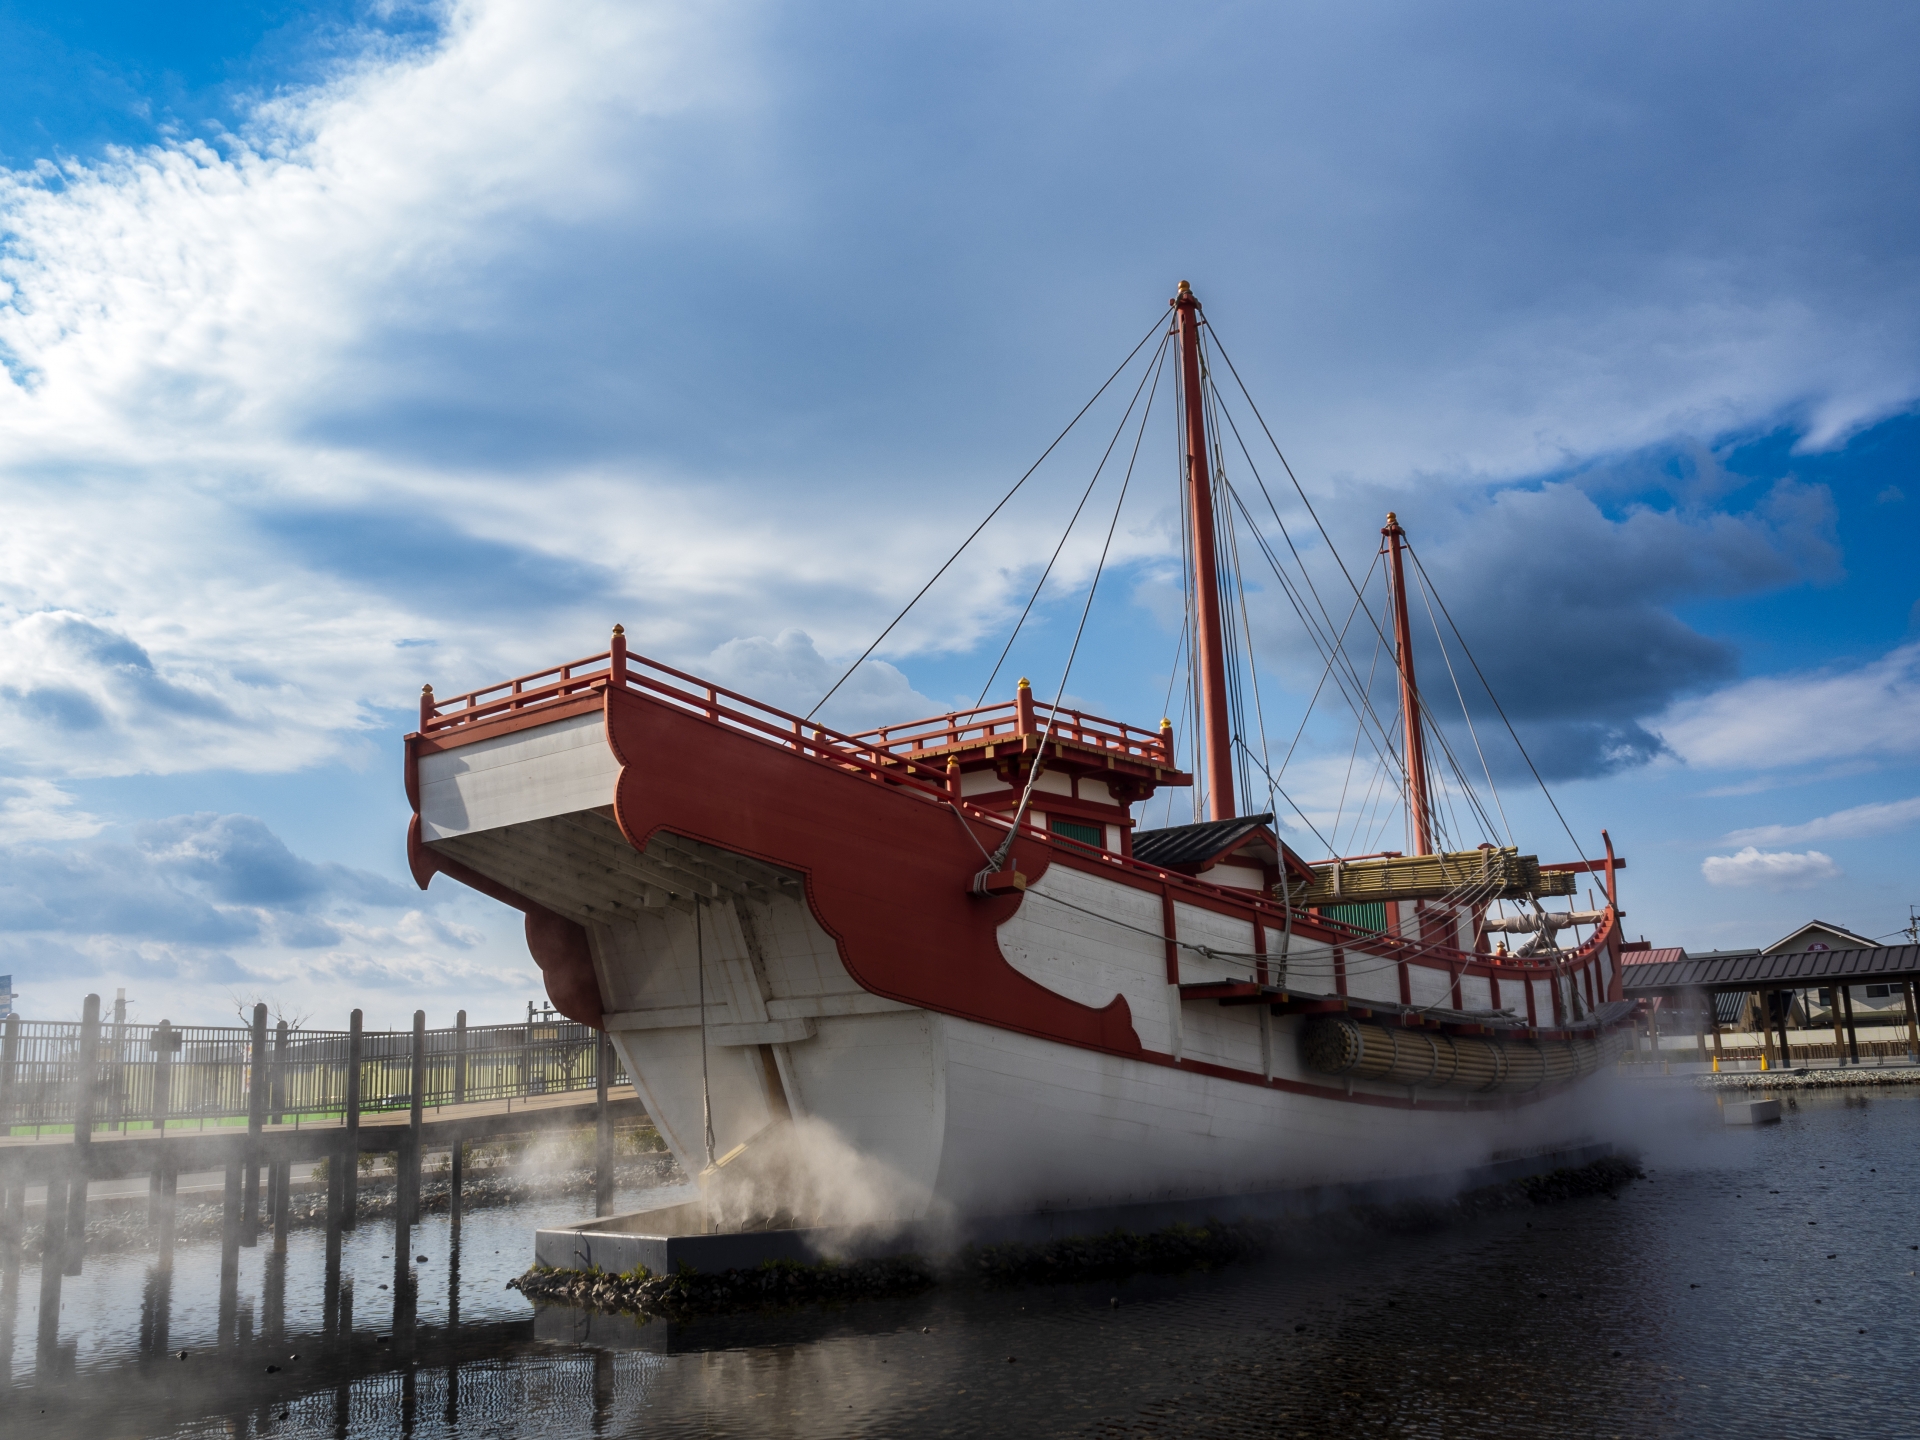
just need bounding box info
[0,1089,1920,1440]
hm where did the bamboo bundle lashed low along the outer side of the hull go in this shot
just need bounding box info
[1300,1016,1624,1092]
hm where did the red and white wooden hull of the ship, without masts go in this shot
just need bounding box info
[407,636,1626,1219]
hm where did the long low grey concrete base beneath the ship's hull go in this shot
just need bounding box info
[534,1144,1620,1275]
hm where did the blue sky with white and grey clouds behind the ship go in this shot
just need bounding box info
[0,0,1920,1025]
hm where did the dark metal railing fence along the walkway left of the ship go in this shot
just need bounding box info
[0,1016,628,1135]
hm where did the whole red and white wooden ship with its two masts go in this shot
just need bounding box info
[405,282,1632,1223]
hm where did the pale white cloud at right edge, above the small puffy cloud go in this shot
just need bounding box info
[1653,643,1920,770]
